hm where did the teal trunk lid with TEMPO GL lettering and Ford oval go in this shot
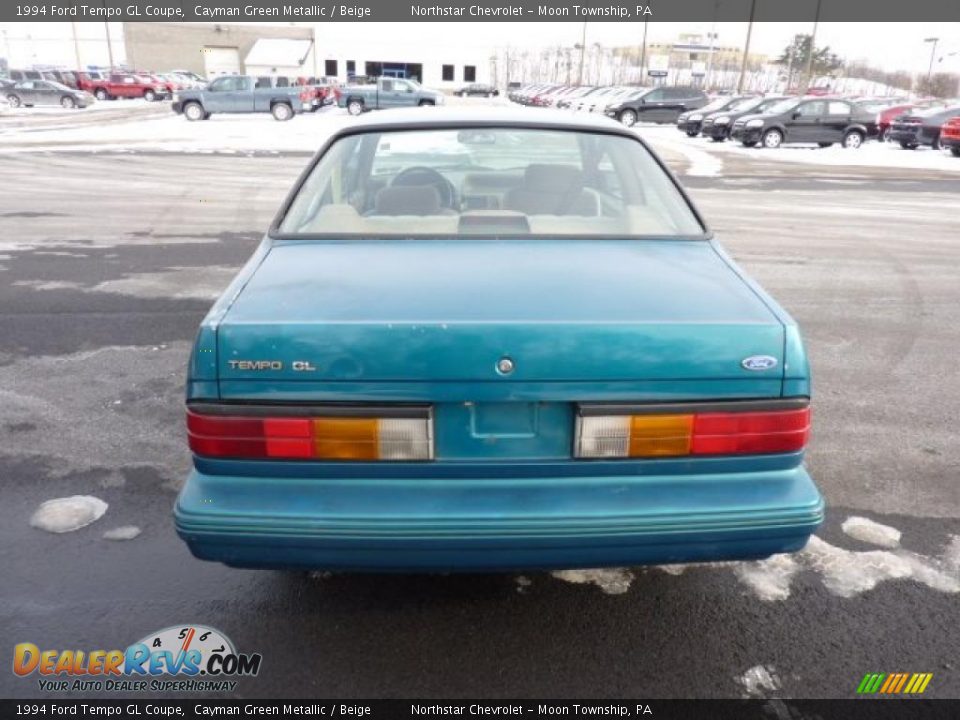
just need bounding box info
[217,240,784,388]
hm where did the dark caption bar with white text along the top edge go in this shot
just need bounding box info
[0,0,960,22]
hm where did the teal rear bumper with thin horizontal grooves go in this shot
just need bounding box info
[174,466,824,571]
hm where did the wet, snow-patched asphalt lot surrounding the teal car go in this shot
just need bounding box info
[0,105,960,698]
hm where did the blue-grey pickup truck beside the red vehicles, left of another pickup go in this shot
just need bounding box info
[171,75,313,121]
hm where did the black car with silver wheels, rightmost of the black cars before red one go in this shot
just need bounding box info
[730,97,876,149]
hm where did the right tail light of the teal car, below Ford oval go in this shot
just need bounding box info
[574,404,810,458]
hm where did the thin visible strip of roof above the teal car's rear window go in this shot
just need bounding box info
[339,107,636,137]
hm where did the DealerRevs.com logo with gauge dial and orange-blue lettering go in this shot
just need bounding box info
[13,625,262,692]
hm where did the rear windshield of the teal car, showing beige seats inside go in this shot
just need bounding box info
[279,128,704,237]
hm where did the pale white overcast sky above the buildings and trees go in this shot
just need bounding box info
[0,21,960,73]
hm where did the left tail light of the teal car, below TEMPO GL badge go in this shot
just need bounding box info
[187,409,433,461]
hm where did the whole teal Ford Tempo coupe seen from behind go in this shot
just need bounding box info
[175,108,824,571]
